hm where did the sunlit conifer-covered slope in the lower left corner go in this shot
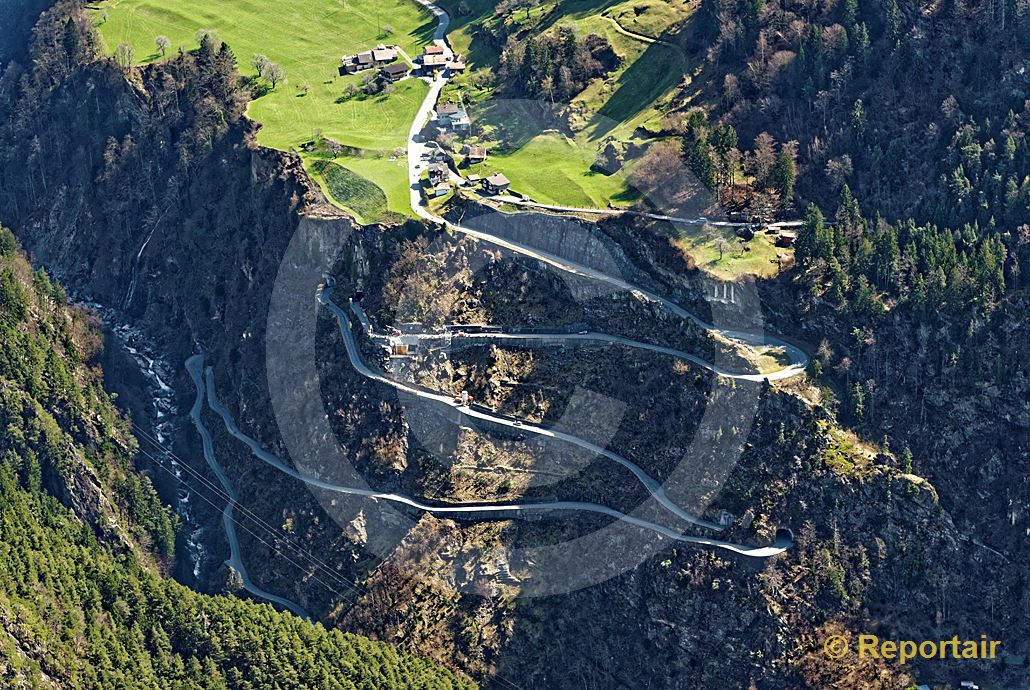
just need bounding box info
[0,229,473,690]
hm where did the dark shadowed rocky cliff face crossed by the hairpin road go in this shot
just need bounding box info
[0,6,1013,690]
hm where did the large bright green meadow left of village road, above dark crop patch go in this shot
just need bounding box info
[93,0,435,150]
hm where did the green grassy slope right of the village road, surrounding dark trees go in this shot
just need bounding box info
[441,0,692,208]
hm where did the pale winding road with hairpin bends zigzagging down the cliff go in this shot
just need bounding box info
[186,0,791,568]
